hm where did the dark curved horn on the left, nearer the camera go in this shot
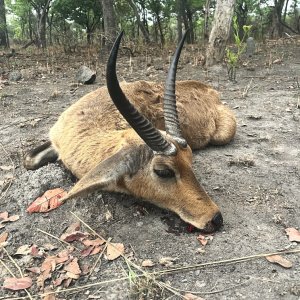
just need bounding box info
[106,31,176,155]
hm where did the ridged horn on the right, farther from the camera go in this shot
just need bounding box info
[164,30,188,147]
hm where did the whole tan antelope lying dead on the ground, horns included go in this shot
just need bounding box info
[25,33,236,232]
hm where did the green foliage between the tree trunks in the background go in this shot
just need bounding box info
[5,0,299,47]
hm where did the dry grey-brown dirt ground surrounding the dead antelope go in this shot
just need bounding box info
[0,41,300,300]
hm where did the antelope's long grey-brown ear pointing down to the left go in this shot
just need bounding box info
[63,144,153,201]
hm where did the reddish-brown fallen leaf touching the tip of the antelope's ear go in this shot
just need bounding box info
[27,188,67,213]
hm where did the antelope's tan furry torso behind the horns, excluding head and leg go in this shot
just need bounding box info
[50,81,236,178]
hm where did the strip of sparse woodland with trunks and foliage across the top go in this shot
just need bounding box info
[0,0,300,65]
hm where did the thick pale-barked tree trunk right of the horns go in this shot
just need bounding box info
[206,0,235,67]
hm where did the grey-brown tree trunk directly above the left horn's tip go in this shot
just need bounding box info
[101,0,117,49]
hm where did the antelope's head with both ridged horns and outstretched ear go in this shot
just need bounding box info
[68,32,223,232]
